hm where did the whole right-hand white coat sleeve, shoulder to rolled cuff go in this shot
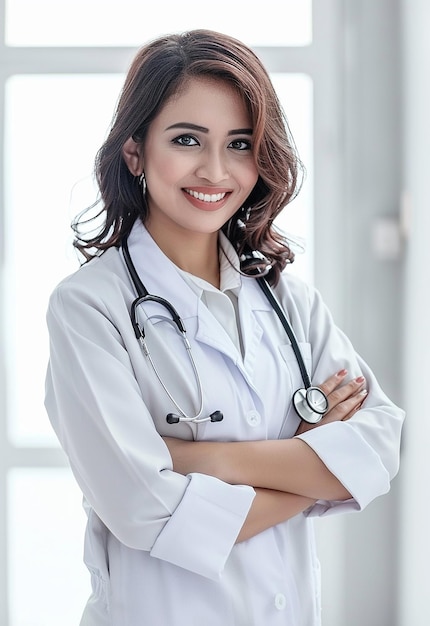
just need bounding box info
[280,274,405,515]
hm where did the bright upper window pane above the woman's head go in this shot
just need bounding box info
[5,0,312,47]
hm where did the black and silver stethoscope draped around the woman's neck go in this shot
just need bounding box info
[122,238,329,424]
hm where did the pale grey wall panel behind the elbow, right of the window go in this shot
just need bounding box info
[315,0,404,626]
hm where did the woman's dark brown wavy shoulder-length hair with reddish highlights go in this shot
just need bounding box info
[72,30,302,284]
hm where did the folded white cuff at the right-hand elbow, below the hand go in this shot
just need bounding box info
[298,422,390,510]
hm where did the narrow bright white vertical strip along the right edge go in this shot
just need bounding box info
[400,0,430,626]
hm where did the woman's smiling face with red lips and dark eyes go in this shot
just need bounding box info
[141,78,258,240]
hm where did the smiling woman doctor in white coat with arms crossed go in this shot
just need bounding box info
[46,31,403,626]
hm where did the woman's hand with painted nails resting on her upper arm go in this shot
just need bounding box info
[295,370,367,435]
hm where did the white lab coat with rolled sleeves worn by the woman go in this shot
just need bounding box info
[46,217,403,626]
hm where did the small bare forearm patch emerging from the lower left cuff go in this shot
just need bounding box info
[236,489,315,543]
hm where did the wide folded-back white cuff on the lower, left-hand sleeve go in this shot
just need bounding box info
[151,474,255,580]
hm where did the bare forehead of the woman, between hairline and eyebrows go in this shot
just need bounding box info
[154,77,251,128]
